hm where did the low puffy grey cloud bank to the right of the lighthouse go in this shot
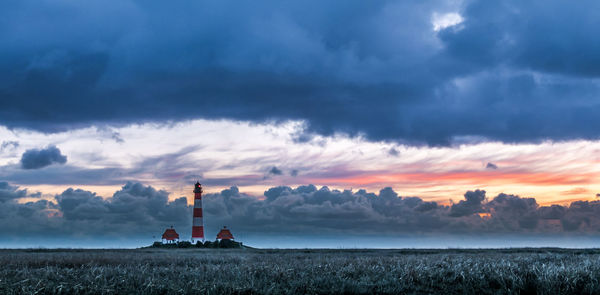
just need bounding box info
[204,185,600,235]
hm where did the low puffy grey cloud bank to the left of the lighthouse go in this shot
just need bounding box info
[0,183,191,239]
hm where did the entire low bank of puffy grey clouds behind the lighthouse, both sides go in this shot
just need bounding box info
[0,182,600,238]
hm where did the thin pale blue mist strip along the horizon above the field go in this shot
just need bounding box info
[7,235,600,249]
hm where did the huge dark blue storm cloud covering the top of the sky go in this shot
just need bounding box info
[0,0,600,145]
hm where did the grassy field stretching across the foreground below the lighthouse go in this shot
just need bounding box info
[0,249,600,294]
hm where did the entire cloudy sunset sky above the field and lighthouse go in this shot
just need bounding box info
[0,0,600,248]
